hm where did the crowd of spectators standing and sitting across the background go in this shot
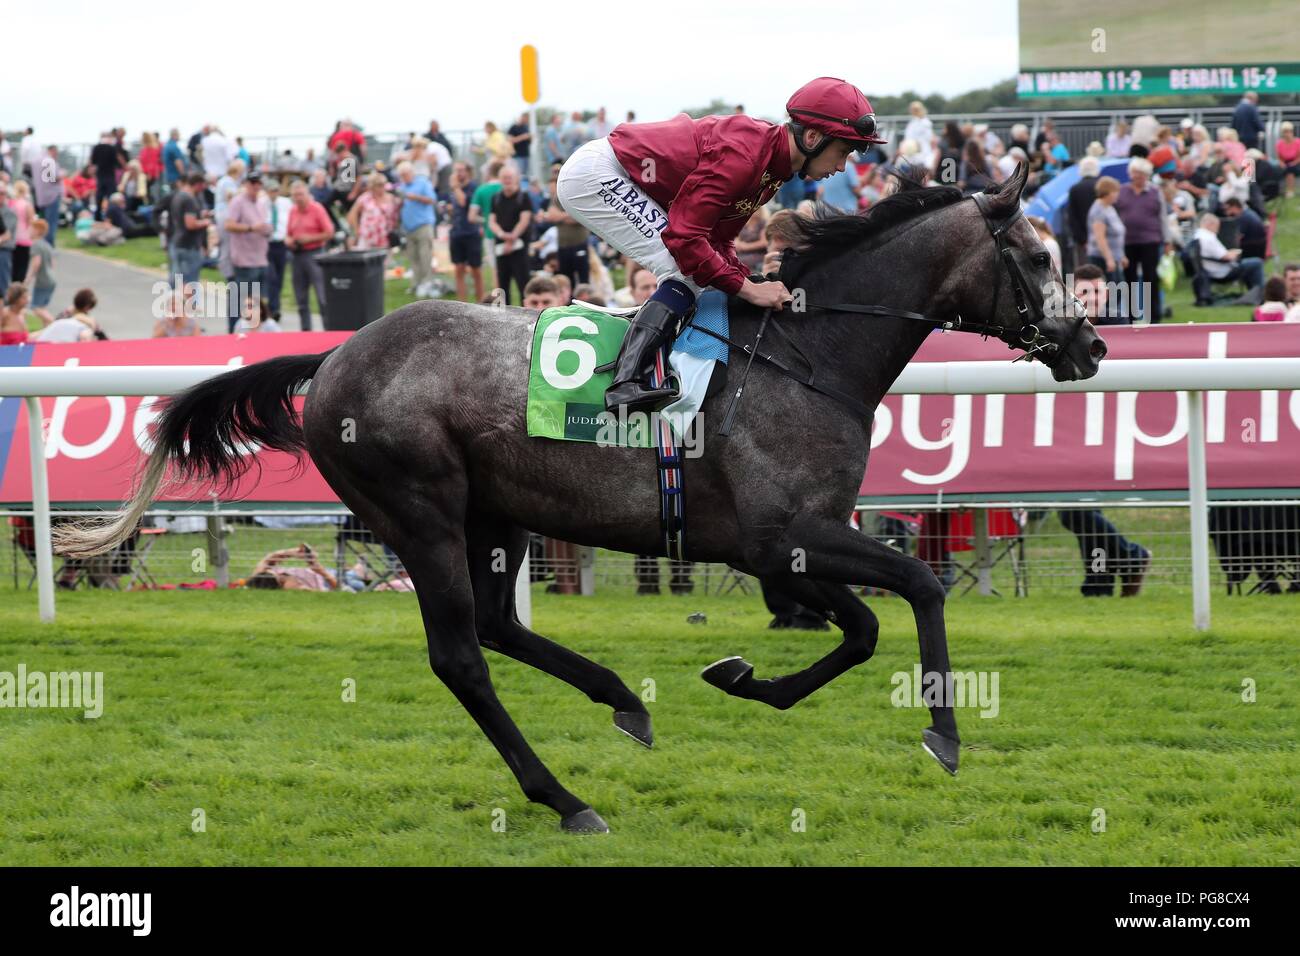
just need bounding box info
[0,94,1300,343]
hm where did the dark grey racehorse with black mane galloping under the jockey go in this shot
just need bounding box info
[56,166,1105,832]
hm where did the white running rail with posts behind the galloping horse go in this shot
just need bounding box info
[0,358,1300,631]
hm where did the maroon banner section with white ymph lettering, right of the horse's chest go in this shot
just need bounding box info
[861,323,1300,498]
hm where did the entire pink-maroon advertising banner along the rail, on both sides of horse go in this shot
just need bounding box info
[0,323,1300,503]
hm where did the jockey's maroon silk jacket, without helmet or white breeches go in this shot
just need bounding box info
[606,113,793,295]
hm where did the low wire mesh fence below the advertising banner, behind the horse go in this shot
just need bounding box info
[0,498,1300,602]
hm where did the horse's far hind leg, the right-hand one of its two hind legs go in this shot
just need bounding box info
[467,516,654,747]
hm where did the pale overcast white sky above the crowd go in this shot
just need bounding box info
[17,0,1018,143]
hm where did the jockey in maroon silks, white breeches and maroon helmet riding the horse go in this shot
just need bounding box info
[555,77,885,411]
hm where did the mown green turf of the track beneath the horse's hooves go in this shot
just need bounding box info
[0,588,1300,865]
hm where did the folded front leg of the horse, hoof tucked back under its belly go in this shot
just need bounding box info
[701,575,880,710]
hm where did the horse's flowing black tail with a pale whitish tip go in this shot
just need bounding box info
[52,352,330,558]
